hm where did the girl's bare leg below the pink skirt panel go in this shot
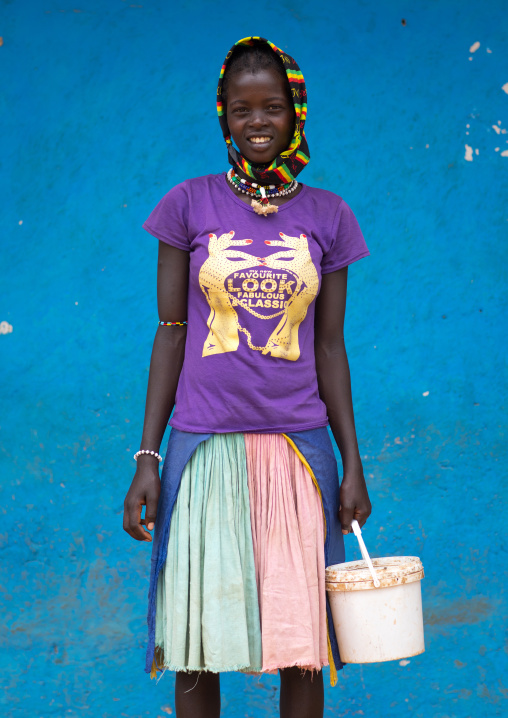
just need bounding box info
[280,667,324,718]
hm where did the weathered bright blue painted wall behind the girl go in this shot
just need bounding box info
[0,0,508,718]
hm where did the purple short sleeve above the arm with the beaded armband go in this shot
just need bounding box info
[143,182,190,252]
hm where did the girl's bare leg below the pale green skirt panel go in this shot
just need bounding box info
[175,671,220,718]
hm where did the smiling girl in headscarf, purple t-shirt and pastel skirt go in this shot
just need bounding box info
[124,37,371,718]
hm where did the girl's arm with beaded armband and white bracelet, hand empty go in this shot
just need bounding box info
[123,242,189,541]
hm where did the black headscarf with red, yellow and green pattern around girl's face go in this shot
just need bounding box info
[217,37,310,185]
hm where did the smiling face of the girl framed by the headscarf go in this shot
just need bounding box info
[226,68,295,165]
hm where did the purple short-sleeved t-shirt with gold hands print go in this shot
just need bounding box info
[143,174,369,433]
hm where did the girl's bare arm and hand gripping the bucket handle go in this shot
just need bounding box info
[315,267,372,534]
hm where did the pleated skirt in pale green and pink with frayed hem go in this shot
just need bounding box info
[155,433,328,673]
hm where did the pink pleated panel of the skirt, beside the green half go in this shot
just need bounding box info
[244,434,328,671]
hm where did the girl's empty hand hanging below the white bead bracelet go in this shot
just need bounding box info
[123,454,161,541]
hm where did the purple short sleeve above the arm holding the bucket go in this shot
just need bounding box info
[321,200,370,274]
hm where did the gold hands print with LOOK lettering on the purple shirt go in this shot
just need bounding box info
[199,231,319,361]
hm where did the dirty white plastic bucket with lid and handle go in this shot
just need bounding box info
[326,527,425,663]
